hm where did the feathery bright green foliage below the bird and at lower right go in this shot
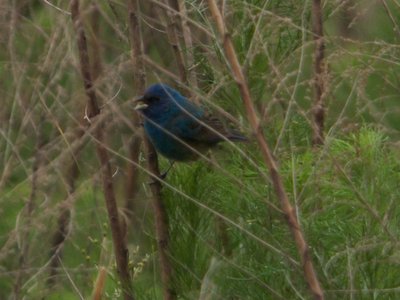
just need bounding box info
[132,127,400,299]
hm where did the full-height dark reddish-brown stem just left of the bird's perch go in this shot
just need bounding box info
[71,0,134,300]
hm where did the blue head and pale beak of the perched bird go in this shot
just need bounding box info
[134,83,183,119]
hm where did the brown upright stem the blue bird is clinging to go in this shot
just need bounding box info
[128,0,176,300]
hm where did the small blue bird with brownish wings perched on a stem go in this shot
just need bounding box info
[135,84,247,161]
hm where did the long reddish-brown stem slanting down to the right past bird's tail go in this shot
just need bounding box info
[208,0,324,299]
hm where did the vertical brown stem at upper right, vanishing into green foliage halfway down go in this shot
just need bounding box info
[312,0,326,145]
